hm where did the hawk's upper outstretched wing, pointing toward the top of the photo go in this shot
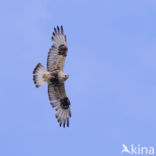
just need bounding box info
[47,26,68,71]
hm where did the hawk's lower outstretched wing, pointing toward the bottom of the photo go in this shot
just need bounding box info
[48,84,71,127]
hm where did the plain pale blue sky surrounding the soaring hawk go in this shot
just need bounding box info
[0,0,156,156]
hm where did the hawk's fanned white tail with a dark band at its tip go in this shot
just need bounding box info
[33,63,48,88]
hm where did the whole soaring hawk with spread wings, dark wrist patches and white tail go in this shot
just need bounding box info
[33,26,71,127]
